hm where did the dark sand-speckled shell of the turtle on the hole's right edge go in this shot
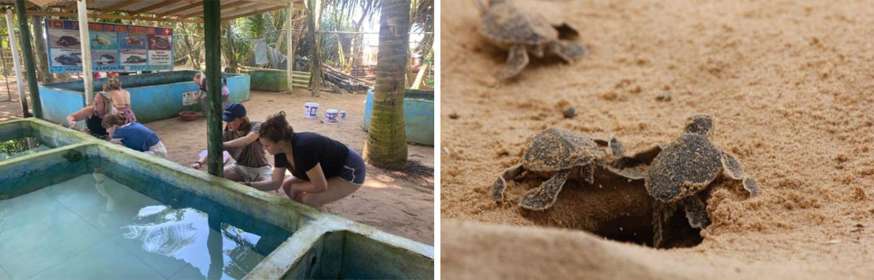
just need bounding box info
[645,133,722,203]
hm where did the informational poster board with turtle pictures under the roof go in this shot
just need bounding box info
[46,19,173,73]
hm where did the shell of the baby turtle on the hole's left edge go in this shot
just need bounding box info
[522,128,606,172]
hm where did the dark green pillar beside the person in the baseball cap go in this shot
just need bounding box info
[202,0,224,176]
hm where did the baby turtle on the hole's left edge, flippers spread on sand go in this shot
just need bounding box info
[491,128,623,210]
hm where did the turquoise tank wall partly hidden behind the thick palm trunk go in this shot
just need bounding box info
[363,89,434,146]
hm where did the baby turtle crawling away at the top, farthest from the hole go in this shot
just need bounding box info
[476,0,586,80]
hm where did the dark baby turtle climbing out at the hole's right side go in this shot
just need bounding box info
[644,115,759,247]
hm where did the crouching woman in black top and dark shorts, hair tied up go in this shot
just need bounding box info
[249,112,366,207]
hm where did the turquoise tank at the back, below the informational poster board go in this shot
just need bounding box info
[39,71,251,123]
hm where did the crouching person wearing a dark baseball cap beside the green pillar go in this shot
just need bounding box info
[192,104,273,182]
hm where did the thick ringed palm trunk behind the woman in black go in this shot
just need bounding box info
[364,0,410,169]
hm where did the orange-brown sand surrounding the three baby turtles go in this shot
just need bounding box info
[441,0,874,279]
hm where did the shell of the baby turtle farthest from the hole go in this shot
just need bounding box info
[480,3,559,47]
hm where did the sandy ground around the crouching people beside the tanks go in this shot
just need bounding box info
[0,84,434,244]
